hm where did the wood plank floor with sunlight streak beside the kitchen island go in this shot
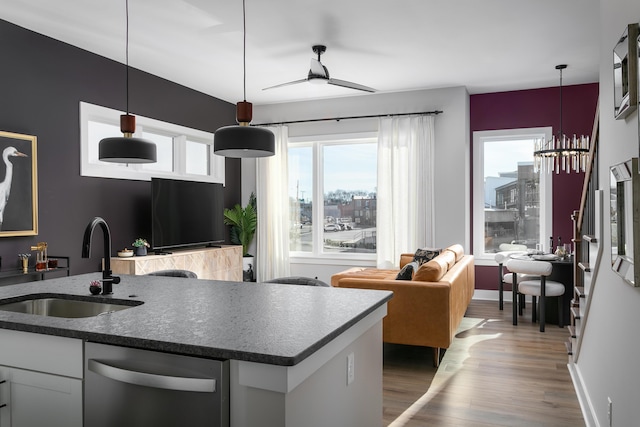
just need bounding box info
[383,300,585,427]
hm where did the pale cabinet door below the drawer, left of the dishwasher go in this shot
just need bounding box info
[0,366,82,427]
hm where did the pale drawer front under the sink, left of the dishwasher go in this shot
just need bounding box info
[0,329,83,378]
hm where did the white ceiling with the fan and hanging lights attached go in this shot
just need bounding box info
[0,0,599,104]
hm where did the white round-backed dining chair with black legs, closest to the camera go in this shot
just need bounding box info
[505,259,564,332]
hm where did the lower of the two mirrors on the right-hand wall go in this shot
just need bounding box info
[610,157,640,286]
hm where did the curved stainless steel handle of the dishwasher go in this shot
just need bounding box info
[87,359,216,393]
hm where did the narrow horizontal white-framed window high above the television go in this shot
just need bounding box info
[80,102,224,184]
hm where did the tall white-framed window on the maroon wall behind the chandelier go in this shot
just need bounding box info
[473,128,552,265]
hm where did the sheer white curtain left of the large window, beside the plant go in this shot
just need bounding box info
[256,126,290,282]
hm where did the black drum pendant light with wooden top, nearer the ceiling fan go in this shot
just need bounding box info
[213,0,276,158]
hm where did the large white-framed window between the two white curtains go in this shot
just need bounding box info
[288,134,378,259]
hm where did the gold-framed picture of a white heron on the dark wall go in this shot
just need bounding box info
[0,131,38,237]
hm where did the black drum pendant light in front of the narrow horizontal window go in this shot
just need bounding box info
[98,0,157,163]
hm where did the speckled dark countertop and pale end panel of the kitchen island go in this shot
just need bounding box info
[0,273,392,427]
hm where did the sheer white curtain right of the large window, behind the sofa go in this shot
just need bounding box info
[376,115,435,268]
